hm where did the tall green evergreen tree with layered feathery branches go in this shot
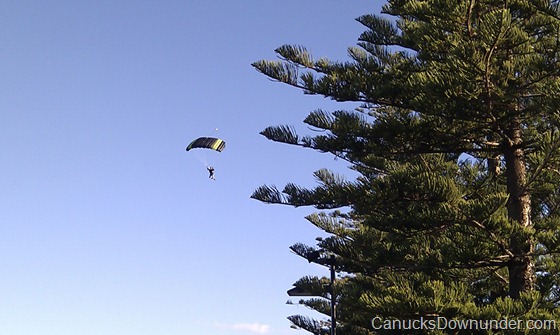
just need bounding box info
[252,0,560,334]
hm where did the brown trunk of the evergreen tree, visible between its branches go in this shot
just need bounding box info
[504,120,534,299]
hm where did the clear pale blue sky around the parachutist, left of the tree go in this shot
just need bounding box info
[0,0,381,335]
